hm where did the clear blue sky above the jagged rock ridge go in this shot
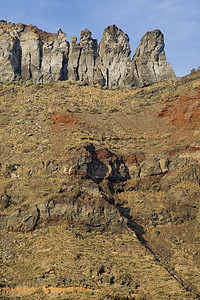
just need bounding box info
[0,0,200,77]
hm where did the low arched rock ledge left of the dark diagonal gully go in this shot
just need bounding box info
[4,194,126,232]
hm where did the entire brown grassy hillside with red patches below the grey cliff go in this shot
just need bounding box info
[0,71,200,299]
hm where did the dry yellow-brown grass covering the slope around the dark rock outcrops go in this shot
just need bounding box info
[0,73,200,299]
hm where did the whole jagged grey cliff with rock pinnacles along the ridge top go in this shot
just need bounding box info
[0,21,175,87]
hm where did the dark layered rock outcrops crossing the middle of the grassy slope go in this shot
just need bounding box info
[0,144,200,231]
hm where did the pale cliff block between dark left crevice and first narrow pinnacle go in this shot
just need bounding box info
[20,26,68,83]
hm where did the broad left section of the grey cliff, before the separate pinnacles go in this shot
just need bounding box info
[0,21,69,83]
